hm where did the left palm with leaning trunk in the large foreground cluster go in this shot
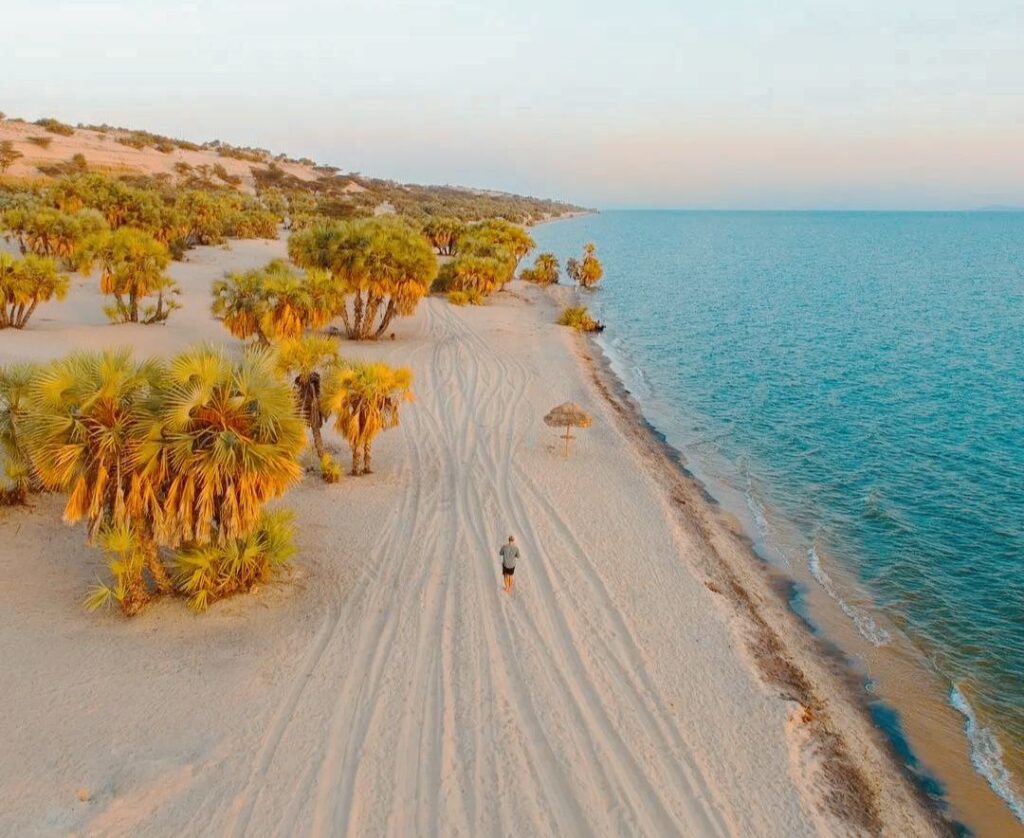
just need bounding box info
[19,349,171,615]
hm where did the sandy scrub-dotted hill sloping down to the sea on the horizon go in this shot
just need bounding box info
[0,119,584,223]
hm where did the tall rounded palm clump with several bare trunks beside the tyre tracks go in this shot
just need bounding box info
[288,218,437,340]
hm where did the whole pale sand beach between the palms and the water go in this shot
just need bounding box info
[0,240,943,836]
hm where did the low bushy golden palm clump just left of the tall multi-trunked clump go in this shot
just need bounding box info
[211,259,343,346]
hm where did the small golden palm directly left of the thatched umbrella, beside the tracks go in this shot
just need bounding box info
[324,364,413,475]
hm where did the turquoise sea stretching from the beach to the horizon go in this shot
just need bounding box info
[532,212,1024,820]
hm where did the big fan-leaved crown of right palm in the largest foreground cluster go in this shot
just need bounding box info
[140,347,305,547]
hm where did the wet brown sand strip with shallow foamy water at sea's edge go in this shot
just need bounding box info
[580,317,1024,835]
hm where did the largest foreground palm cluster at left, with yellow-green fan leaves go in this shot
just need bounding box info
[0,348,304,616]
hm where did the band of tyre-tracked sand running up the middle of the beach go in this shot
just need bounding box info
[197,301,815,835]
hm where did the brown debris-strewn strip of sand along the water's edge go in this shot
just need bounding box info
[561,315,957,835]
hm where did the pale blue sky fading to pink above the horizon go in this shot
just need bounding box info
[0,0,1024,209]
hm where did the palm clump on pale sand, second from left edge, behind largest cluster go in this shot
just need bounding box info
[76,227,180,324]
